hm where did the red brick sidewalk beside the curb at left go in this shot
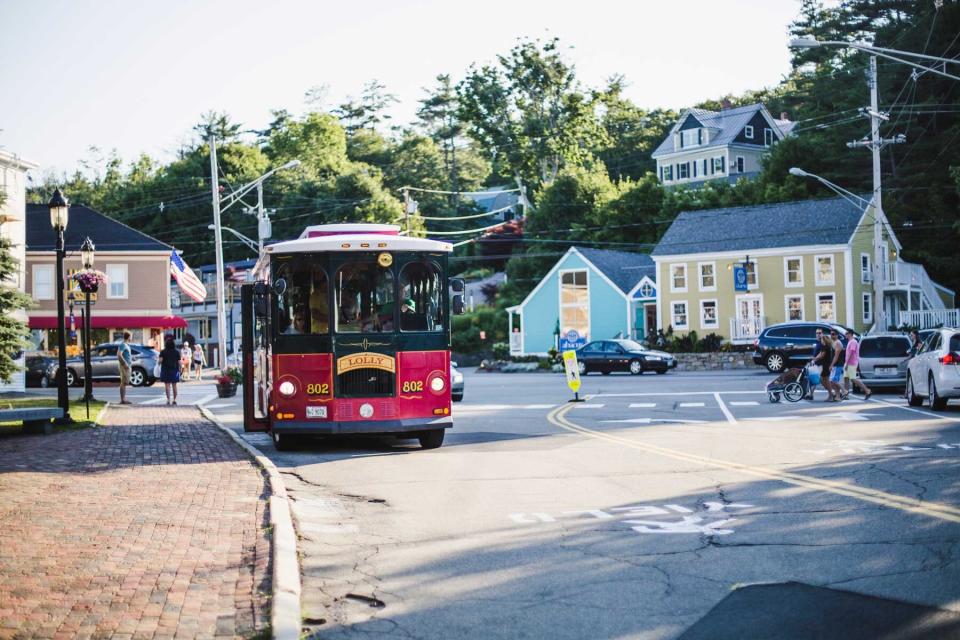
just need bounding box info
[0,406,270,638]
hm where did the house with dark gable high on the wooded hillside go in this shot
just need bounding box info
[652,103,795,186]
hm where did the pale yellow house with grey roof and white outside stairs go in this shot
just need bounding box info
[651,198,956,344]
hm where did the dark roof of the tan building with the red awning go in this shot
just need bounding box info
[26,204,173,251]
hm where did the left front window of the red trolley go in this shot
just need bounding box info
[276,261,330,335]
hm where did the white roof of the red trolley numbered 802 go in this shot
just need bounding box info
[264,223,453,254]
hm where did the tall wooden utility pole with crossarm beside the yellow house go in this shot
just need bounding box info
[847,56,907,331]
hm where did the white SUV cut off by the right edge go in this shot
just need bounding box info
[906,329,960,411]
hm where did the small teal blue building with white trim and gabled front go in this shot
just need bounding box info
[507,247,657,355]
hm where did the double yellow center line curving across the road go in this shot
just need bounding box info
[547,405,960,522]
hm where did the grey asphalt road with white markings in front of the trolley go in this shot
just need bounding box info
[47,370,960,638]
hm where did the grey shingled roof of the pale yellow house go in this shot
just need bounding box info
[652,198,864,256]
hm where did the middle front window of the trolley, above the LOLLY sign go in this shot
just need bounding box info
[334,262,394,333]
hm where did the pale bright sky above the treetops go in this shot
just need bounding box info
[0,0,800,174]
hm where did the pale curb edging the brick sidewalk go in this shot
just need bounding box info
[199,407,302,640]
